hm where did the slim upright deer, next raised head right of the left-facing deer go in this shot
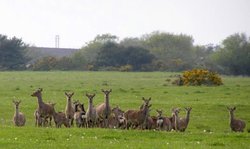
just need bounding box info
[65,92,74,126]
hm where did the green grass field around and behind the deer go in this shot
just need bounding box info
[0,71,250,149]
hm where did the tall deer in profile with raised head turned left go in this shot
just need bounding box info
[31,88,54,126]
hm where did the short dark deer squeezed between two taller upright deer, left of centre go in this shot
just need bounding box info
[74,103,87,128]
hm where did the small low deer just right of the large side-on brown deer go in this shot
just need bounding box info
[156,110,172,131]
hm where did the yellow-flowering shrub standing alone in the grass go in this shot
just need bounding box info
[173,69,223,86]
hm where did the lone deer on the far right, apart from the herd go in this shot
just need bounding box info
[227,107,246,132]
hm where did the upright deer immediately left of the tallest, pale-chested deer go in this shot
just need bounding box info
[86,94,98,128]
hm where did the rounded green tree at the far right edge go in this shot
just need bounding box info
[213,33,250,75]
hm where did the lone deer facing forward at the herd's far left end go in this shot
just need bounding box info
[13,100,26,126]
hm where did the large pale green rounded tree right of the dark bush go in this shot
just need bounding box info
[142,32,193,71]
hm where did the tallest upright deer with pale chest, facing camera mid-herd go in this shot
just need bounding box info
[96,89,112,128]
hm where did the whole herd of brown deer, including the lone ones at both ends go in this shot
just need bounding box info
[13,88,246,132]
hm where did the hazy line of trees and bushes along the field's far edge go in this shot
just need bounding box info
[0,31,250,75]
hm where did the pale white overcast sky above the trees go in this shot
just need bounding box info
[0,0,250,48]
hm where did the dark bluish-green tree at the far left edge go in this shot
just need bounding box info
[0,35,28,70]
